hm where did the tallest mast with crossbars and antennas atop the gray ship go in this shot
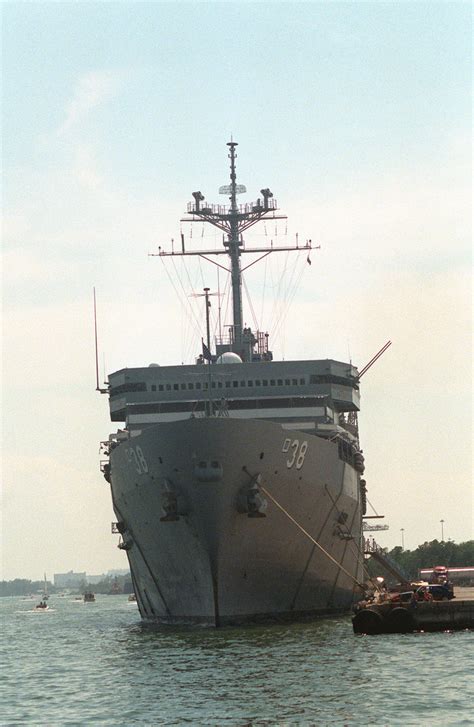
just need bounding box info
[149,140,311,360]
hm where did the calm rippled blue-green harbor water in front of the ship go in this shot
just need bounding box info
[0,596,474,727]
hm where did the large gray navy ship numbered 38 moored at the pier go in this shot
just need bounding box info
[101,141,366,626]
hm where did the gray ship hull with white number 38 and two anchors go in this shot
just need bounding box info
[110,417,362,626]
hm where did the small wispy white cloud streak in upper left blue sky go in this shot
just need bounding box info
[57,70,121,136]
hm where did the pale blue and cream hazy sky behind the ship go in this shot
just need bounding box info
[0,1,474,580]
